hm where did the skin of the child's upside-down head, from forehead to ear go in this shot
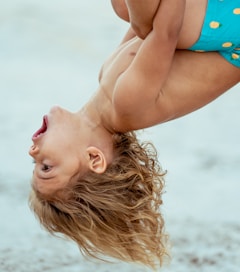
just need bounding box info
[29,106,113,194]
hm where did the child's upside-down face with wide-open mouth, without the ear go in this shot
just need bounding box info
[29,107,84,194]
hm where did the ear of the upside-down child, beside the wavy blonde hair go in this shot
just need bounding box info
[87,146,107,174]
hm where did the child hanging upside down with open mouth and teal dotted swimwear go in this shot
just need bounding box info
[29,0,240,267]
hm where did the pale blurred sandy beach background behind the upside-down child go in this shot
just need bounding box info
[0,0,240,272]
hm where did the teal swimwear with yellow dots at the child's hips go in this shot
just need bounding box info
[189,0,240,68]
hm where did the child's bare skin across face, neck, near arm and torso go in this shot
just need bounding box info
[29,0,240,193]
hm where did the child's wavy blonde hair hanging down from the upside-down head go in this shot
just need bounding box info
[29,132,168,268]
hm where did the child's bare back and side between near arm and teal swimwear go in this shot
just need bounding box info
[113,50,240,131]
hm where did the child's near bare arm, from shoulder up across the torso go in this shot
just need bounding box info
[113,0,185,130]
